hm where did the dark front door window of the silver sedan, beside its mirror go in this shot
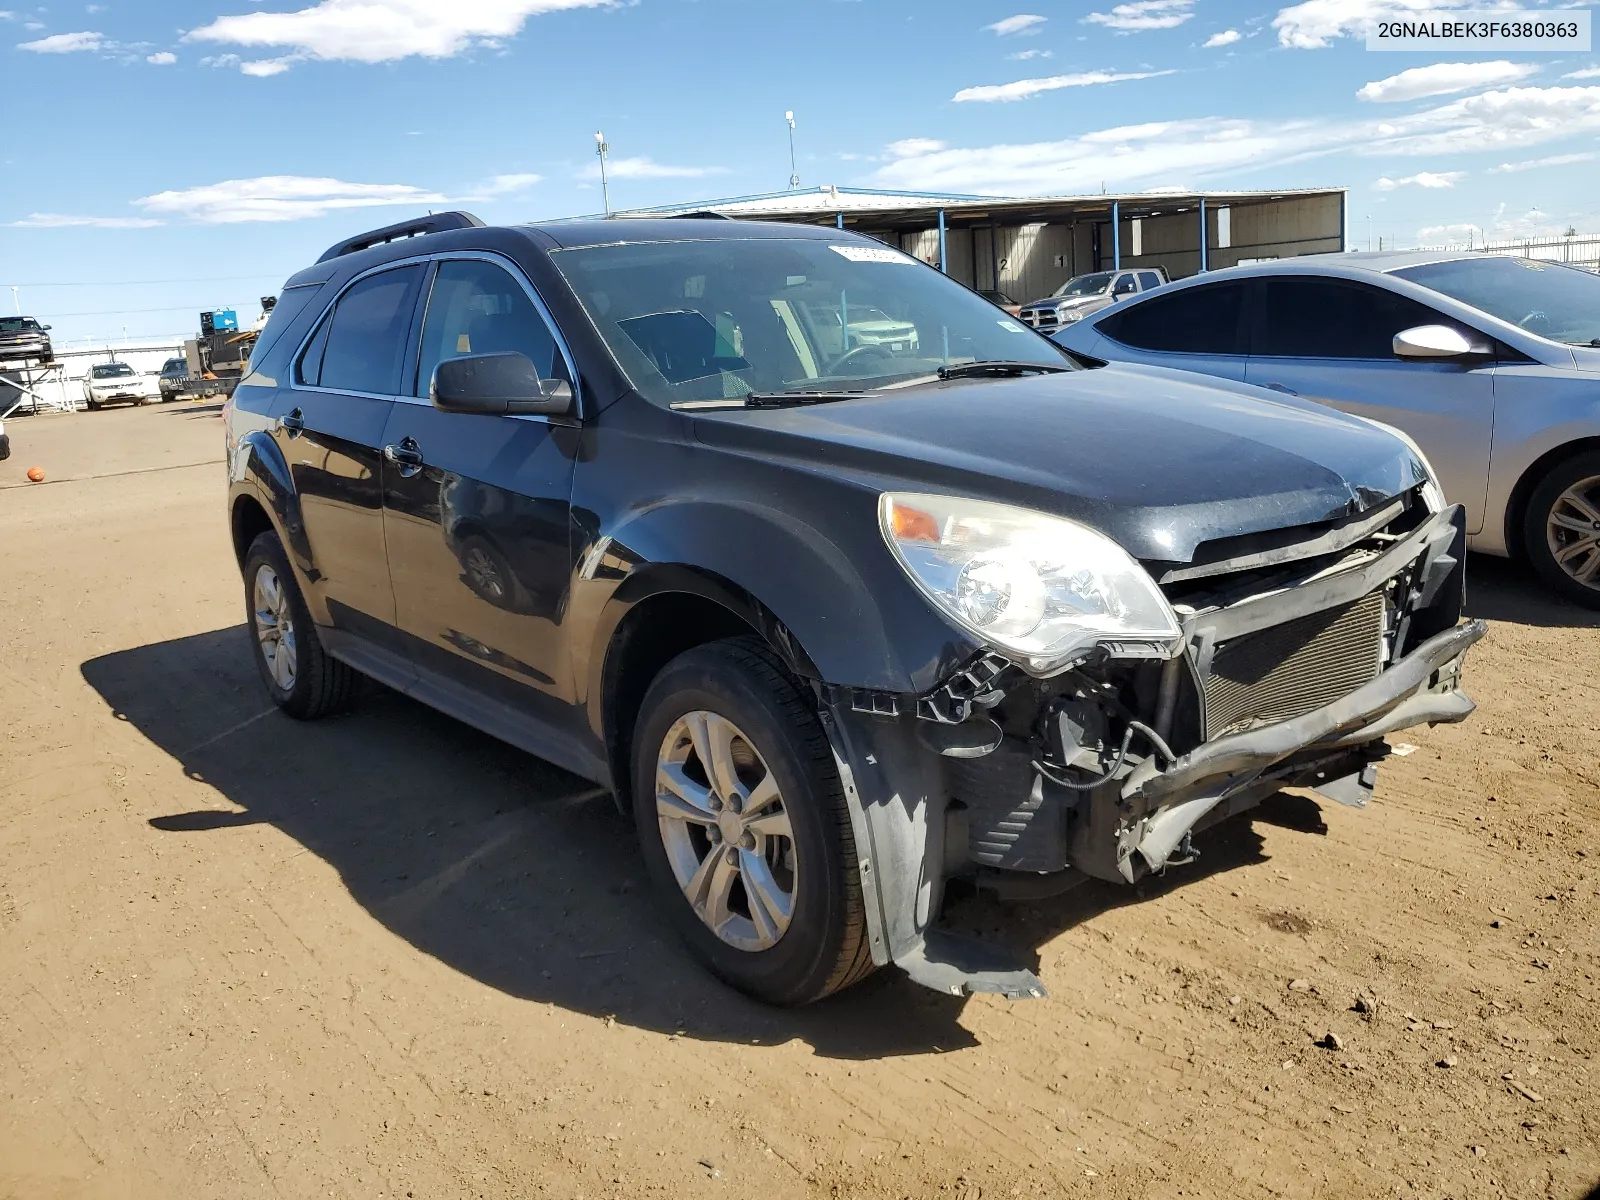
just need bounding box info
[1250,275,1445,358]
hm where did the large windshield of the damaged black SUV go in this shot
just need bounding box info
[552,238,1070,403]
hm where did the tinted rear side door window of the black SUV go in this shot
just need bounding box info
[299,262,424,395]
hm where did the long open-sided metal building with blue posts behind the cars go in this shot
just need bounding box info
[618,186,1346,302]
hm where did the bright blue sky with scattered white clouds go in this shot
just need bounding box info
[0,0,1600,342]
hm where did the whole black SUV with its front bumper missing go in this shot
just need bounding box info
[227,213,1483,1003]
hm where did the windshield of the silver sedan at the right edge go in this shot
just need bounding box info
[1392,254,1600,346]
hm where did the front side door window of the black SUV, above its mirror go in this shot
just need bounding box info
[413,259,571,397]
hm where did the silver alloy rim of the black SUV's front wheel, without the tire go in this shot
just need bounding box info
[656,712,798,950]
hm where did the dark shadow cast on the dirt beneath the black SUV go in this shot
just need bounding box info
[82,626,1280,1059]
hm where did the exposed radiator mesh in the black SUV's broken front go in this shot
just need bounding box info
[1205,592,1384,739]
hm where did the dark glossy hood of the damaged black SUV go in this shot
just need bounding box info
[696,363,1426,563]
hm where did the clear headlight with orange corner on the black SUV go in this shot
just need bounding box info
[878,493,1182,675]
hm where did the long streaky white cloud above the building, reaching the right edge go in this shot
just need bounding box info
[870,86,1600,195]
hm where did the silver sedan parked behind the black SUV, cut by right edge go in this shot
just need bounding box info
[1054,253,1600,608]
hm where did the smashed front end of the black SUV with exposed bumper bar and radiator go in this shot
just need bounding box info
[821,486,1485,998]
